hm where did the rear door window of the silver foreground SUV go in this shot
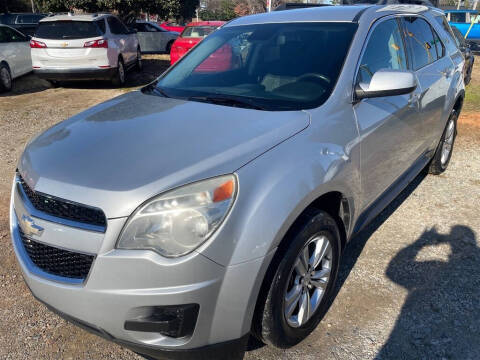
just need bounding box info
[404,16,437,70]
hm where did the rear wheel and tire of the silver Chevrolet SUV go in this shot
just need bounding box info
[428,109,459,175]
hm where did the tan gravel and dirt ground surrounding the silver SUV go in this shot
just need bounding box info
[0,56,480,360]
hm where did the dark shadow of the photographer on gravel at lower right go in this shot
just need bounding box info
[375,225,480,360]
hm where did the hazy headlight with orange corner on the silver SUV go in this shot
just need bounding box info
[117,175,237,257]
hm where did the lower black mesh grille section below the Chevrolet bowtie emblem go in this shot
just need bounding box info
[20,232,94,279]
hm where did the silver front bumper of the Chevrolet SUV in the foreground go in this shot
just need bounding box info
[10,179,273,358]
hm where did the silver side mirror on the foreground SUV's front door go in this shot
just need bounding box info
[355,69,417,100]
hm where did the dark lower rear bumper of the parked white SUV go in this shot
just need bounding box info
[33,68,117,81]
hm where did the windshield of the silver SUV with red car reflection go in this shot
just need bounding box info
[150,22,357,111]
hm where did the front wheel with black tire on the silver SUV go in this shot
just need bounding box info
[252,210,340,348]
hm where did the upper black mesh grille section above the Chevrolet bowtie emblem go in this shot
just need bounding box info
[18,175,107,227]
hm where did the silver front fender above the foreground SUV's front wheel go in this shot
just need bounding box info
[200,128,360,266]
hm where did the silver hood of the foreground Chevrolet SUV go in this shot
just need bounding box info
[19,91,309,218]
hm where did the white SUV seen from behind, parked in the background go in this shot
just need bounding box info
[30,13,142,85]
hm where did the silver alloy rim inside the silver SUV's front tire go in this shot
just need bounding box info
[283,235,332,328]
